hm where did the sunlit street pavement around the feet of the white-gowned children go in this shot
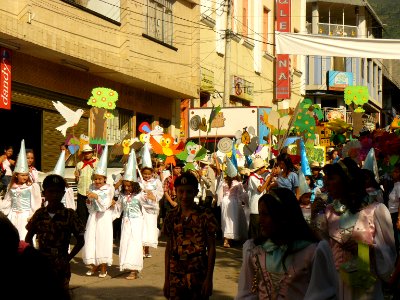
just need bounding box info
[70,238,242,300]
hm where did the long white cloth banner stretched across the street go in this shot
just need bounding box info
[275,32,400,59]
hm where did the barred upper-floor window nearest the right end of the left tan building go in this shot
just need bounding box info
[146,0,173,45]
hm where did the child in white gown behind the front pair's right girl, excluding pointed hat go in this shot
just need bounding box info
[140,167,164,257]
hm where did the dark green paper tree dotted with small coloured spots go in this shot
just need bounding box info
[294,99,324,140]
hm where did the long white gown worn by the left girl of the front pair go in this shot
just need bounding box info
[82,184,114,266]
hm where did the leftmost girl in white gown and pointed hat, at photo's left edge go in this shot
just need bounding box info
[0,140,42,240]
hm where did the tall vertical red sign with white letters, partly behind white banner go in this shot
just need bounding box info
[275,0,291,100]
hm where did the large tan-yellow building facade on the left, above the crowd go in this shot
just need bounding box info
[0,0,200,171]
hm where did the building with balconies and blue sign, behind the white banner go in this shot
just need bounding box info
[305,0,383,128]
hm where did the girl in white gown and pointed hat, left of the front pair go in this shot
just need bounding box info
[82,145,114,278]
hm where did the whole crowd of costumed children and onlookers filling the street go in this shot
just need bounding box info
[0,141,400,300]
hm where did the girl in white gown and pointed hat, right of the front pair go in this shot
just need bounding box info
[115,149,145,280]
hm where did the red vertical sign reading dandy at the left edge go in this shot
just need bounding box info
[0,48,12,109]
